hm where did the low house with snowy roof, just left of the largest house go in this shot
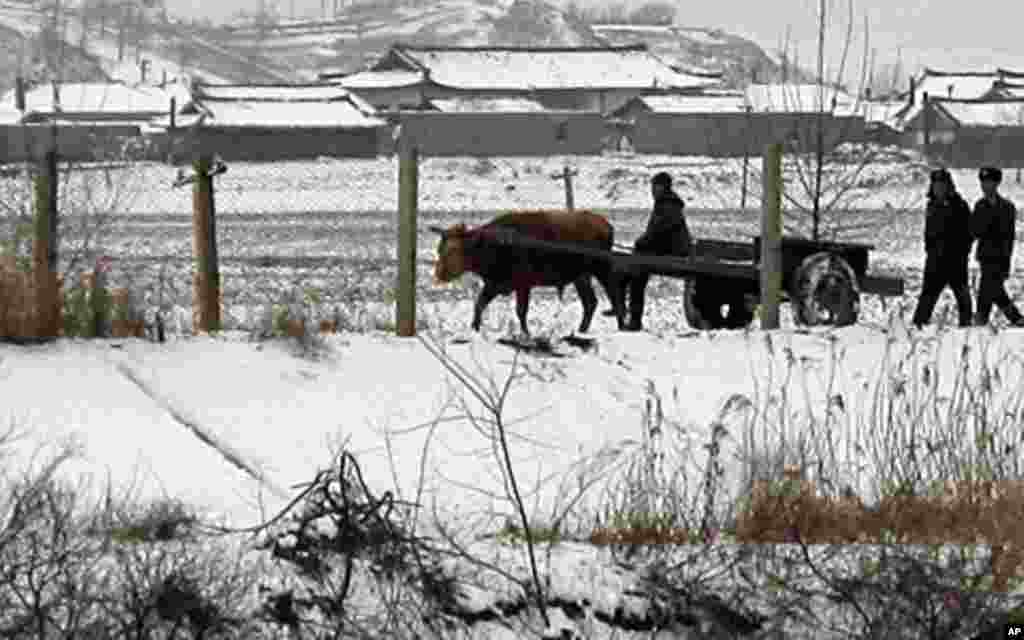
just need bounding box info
[151,83,389,162]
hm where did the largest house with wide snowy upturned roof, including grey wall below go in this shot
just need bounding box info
[321,44,718,156]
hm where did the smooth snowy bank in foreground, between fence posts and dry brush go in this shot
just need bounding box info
[0,327,1024,525]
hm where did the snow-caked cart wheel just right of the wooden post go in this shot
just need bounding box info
[793,252,860,327]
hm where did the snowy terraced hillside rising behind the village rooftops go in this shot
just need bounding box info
[0,0,806,89]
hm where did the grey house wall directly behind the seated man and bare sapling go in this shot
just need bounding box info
[629,113,864,158]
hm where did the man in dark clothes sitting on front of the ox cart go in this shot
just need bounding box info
[604,171,692,331]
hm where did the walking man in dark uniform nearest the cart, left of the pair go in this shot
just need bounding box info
[913,169,973,329]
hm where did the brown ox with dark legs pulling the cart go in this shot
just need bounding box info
[431,211,625,335]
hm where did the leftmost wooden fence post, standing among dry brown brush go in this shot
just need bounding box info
[27,150,60,337]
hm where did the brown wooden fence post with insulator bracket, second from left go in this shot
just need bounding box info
[193,154,220,333]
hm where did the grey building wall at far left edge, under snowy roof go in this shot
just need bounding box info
[0,124,140,163]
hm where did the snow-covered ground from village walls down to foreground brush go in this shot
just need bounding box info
[0,149,1024,637]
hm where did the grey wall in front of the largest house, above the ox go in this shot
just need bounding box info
[385,112,607,156]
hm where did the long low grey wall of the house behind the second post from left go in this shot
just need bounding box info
[163,127,388,164]
